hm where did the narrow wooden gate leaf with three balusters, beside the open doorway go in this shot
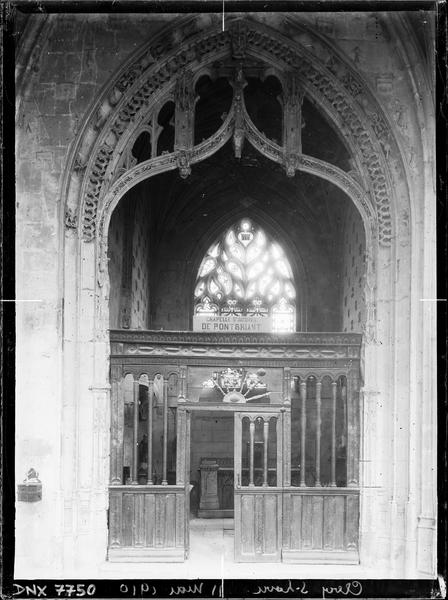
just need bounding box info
[234,407,285,562]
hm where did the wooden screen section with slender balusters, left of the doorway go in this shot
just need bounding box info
[108,370,189,561]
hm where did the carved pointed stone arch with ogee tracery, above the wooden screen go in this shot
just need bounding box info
[67,19,398,246]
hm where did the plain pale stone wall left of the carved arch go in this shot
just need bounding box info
[16,14,173,577]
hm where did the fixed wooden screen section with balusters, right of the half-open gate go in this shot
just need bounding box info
[283,371,359,563]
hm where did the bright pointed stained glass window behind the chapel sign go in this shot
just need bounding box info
[194,219,296,333]
